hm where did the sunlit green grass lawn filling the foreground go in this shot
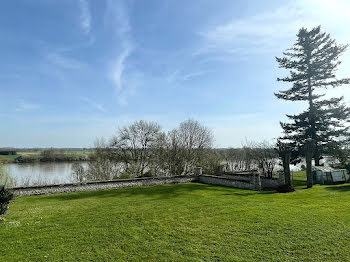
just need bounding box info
[0,173,350,261]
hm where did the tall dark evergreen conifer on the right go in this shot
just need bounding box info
[275,26,350,168]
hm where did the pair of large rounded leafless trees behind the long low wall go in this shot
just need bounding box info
[73,120,218,179]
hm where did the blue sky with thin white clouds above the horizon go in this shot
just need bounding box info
[0,0,350,147]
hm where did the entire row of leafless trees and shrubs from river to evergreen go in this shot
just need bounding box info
[73,119,278,182]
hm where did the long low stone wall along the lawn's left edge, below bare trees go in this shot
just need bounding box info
[13,176,198,196]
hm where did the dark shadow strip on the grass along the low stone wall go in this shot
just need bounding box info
[38,183,276,201]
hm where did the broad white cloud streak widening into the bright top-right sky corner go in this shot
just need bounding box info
[198,0,350,56]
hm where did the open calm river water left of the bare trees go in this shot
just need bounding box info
[5,162,88,186]
